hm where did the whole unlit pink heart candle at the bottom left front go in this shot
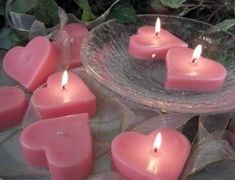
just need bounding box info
[20,114,93,180]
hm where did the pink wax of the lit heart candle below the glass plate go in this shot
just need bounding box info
[111,129,191,180]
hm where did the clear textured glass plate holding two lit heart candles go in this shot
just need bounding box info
[81,15,235,114]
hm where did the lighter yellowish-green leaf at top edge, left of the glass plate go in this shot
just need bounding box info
[74,0,96,21]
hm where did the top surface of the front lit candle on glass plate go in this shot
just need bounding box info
[166,47,227,80]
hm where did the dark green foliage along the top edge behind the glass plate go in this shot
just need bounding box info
[0,0,235,49]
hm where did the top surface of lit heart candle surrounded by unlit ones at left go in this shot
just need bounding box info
[33,72,95,107]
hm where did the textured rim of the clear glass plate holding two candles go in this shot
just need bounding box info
[81,14,235,114]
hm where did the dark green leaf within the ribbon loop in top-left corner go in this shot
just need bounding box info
[11,0,38,13]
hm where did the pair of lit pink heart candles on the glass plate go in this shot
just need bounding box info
[128,18,227,92]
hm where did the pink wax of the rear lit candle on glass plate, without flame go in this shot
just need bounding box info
[128,26,188,60]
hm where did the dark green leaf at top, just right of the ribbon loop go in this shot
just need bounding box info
[35,0,60,27]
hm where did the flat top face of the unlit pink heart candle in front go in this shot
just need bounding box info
[21,113,92,166]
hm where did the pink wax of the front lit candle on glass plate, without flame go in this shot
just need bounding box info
[165,48,227,92]
